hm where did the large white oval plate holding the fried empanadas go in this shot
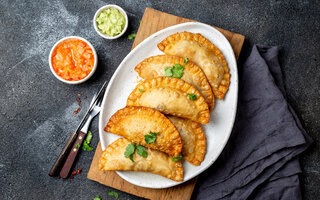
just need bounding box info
[99,22,238,188]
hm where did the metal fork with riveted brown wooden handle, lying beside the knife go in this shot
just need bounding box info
[60,96,103,178]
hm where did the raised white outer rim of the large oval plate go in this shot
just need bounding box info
[99,22,238,189]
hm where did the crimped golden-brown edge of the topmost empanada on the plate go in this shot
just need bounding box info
[157,31,231,99]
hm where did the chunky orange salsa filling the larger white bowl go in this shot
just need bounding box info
[51,38,96,81]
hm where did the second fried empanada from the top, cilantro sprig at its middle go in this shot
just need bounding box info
[134,55,214,110]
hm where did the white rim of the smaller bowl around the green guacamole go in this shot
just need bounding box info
[93,4,129,40]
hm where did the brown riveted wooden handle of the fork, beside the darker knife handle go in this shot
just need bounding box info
[60,131,86,178]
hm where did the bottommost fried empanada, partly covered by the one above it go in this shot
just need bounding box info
[98,138,183,181]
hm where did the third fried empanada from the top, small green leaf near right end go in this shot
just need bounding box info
[127,77,210,124]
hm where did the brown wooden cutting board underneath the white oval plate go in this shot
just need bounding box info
[87,8,244,200]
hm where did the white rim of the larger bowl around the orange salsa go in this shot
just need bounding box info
[49,36,98,84]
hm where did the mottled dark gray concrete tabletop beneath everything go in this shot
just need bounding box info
[0,0,320,199]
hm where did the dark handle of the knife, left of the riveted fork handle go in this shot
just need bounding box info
[49,132,77,176]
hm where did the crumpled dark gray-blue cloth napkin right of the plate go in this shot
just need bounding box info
[193,45,312,200]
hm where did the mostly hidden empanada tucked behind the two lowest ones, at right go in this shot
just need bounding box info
[168,116,206,165]
